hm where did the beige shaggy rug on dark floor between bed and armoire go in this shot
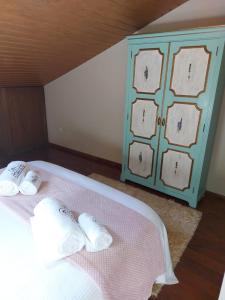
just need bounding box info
[90,173,202,296]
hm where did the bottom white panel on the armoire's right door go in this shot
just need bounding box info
[160,149,193,191]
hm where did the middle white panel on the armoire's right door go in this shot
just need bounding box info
[165,102,202,147]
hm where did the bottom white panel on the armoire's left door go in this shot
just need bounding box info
[128,142,154,178]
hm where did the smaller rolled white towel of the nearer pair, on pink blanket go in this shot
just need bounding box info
[78,213,113,252]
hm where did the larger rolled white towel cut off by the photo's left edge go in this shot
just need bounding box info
[0,161,29,196]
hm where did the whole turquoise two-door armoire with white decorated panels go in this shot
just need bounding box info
[121,26,225,207]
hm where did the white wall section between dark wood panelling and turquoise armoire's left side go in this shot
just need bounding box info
[45,41,127,162]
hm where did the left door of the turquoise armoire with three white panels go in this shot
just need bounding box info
[121,43,168,186]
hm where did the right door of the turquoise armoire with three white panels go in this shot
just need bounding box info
[156,40,222,197]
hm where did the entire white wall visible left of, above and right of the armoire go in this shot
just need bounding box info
[45,0,225,195]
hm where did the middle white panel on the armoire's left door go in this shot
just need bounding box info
[130,99,158,138]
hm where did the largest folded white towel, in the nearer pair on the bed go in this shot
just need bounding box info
[31,197,85,264]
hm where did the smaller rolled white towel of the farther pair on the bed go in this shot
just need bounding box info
[19,171,41,195]
